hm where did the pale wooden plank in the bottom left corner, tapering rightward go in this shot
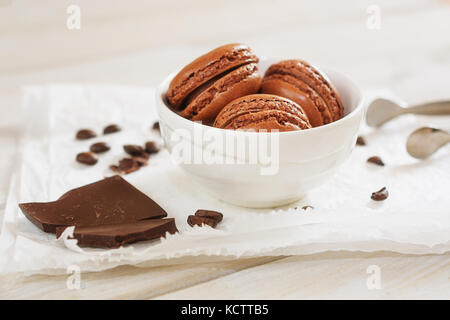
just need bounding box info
[0,257,280,299]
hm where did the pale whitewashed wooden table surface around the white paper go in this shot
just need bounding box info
[0,0,450,299]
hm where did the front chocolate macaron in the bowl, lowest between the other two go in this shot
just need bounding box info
[214,94,311,131]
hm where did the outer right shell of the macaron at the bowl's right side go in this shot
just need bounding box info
[265,60,344,121]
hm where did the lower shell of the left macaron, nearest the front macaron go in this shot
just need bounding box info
[181,63,261,122]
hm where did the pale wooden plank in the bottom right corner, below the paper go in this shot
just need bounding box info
[158,252,450,300]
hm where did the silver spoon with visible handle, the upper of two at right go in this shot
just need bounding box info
[366,98,450,127]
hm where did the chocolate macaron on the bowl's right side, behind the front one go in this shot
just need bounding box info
[261,60,344,127]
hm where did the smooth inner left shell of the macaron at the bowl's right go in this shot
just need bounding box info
[261,78,324,127]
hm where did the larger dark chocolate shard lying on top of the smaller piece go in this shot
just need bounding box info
[19,175,167,233]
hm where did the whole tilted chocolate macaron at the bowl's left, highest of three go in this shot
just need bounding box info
[166,44,261,122]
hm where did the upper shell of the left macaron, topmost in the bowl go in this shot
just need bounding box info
[166,44,258,108]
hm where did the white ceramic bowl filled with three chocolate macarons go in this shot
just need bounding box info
[156,59,364,208]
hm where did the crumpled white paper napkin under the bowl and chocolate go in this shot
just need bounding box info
[0,85,450,274]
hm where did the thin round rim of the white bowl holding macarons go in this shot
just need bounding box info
[155,57,364,136]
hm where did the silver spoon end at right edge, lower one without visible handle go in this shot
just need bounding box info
[406,127,450,159]
